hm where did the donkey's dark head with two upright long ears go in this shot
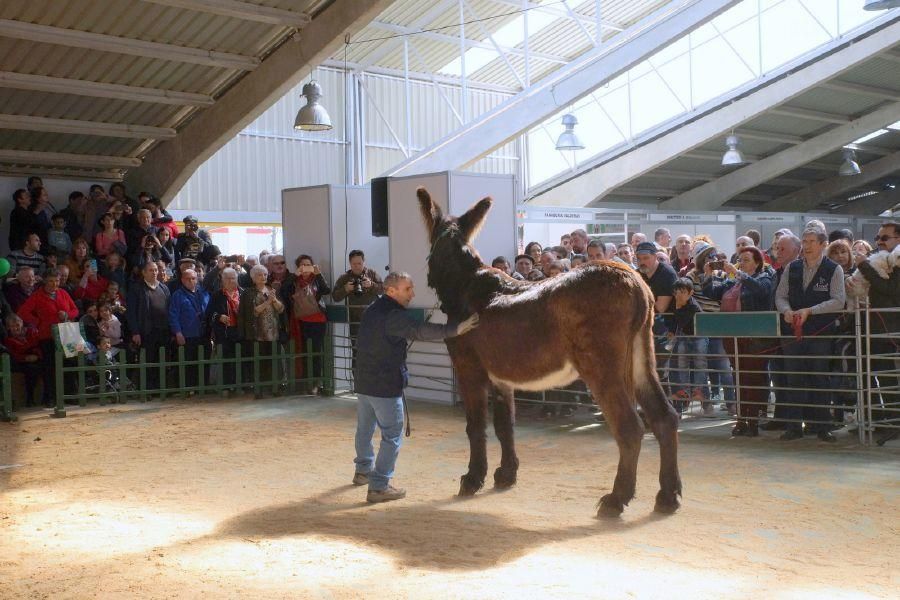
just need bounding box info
[416,187,491,314]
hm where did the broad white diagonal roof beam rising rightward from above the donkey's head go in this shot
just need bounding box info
[385,0,739,176]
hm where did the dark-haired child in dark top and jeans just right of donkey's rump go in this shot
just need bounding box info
[666,277,712,414]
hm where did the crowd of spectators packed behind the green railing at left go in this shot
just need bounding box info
[0,177,382,408]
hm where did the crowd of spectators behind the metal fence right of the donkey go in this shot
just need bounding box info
[492,220,900,442]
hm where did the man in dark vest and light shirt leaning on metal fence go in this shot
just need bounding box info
[775,229,846,442]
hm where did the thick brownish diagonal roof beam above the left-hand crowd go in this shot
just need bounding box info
[125,0,391,203]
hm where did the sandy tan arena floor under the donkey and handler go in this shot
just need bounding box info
[0,398,900,599]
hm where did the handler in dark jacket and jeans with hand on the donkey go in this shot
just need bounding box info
[353,273,478,502]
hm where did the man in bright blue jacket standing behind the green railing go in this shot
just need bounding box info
[169,269,209,387]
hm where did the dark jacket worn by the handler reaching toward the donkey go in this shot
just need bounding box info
[355,295,456,398]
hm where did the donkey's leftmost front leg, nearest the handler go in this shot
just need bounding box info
[456,366,488,496]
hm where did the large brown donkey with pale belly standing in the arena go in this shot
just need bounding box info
[416,188,681,516]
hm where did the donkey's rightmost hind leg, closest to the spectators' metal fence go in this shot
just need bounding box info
[632,330,681,514]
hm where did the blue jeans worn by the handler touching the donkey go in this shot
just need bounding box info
[353,394,403,490]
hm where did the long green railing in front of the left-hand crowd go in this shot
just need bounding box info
[47,336,334,417]
